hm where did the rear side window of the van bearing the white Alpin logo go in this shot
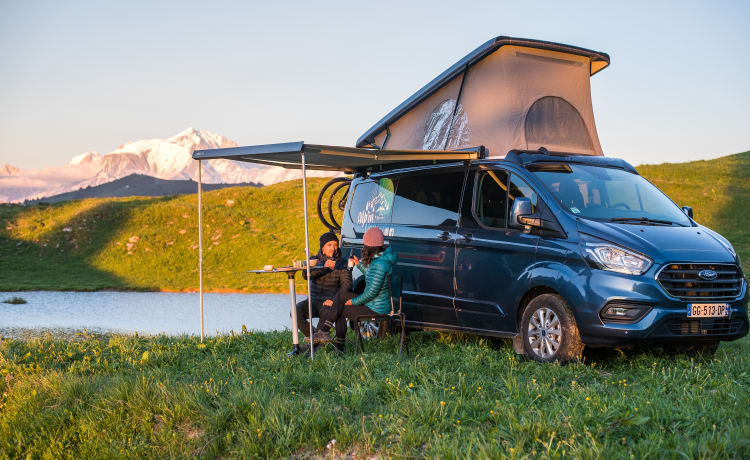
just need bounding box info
[349,177,394,231]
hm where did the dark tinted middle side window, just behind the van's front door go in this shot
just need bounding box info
[393,169,465,226]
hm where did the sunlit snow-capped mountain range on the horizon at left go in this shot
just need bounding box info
[0,128,329,202]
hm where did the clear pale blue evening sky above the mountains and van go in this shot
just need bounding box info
[0,0,750,169]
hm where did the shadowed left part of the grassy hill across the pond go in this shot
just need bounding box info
[0,197,172,291]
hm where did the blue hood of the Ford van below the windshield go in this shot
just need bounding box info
[578,219,736,264]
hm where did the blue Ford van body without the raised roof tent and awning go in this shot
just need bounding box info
[341,149,748,362]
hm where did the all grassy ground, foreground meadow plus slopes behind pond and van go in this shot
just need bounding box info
[0,152,750,459]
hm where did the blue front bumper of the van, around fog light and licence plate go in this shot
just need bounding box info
[575,270,750,345]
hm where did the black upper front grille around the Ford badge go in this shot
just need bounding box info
[657,264,742,300]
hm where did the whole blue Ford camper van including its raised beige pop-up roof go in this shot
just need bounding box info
[341,37,748,362]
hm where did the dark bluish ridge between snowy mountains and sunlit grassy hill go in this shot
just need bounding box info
[27,174,260,204]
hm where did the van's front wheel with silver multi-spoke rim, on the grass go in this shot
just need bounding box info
[520,294,584,363]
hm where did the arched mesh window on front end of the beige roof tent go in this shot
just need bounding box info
[525,96,594,150]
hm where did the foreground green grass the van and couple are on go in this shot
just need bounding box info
[0,332,750,459]
